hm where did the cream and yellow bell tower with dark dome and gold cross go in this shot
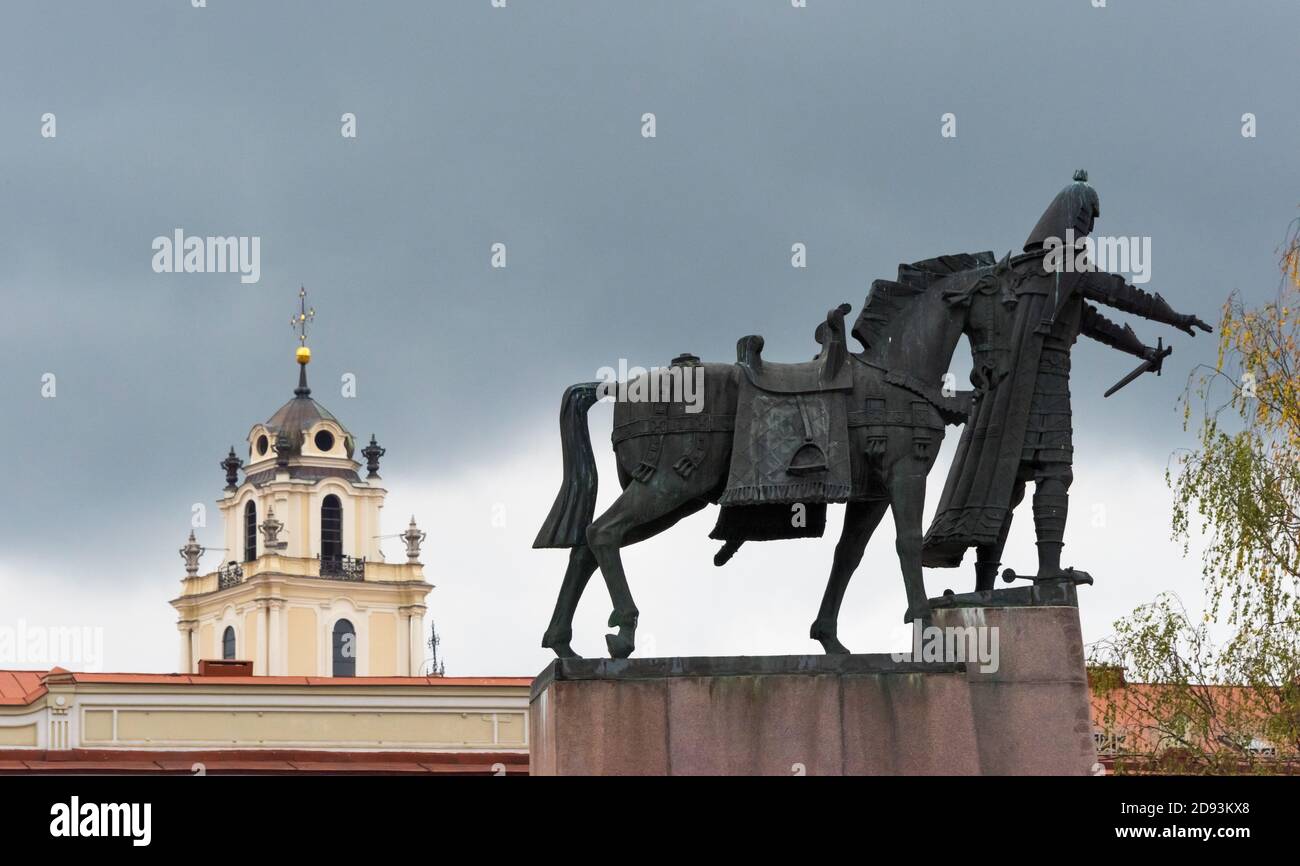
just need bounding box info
[172,290,433,676]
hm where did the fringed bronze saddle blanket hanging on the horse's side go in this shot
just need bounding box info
[719,376,852,506]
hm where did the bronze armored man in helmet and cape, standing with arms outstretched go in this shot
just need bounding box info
[923,172,1210,589]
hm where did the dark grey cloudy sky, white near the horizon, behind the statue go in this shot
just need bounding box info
[0,0,1300,674]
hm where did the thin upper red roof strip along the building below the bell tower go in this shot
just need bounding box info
[0,667,533,706]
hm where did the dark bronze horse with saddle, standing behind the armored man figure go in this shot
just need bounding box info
[533,252,1015,658]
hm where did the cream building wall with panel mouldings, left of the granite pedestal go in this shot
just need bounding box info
[0,675,529,753]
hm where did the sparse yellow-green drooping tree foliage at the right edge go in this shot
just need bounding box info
[1091,221,1300,772]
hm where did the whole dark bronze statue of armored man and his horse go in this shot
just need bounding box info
[533,173,1208,658]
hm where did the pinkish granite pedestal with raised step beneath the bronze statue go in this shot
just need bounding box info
[529,581,1097,775]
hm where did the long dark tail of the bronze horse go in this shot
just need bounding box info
[533,382,602,547]
